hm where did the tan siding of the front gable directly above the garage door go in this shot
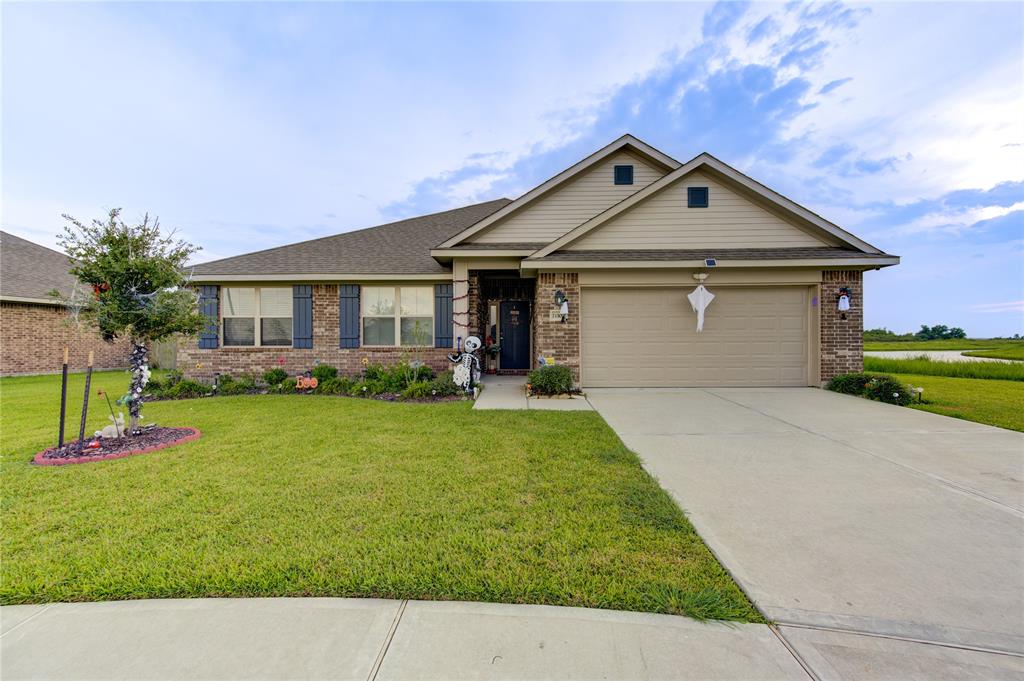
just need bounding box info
[565,171,826,251]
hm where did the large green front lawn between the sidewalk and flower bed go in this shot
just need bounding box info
[0,373,761,622]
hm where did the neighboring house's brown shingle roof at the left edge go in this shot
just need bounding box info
[0,231,78,305]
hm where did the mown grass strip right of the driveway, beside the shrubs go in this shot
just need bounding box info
[895,374,1024,431]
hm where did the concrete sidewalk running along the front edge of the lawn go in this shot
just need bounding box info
[0,598,809,681]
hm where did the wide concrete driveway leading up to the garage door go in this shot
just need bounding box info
[588,388,1024,678]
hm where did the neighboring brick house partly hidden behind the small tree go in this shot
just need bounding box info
[0,231,128,376]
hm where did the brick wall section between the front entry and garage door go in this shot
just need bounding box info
[534,272,580,383]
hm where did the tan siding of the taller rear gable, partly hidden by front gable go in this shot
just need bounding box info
[469,152,666,244]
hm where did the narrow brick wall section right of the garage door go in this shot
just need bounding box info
[819,269,864,382]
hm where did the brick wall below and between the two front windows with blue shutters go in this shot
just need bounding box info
[178,284,452,380]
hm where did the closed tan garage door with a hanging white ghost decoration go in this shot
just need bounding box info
[580,286,811,387]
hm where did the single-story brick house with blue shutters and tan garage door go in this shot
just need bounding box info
[184,135,899,388]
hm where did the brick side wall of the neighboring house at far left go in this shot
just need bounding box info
[0,302,128,376]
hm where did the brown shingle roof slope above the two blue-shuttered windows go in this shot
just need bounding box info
[193,199,510,281]
